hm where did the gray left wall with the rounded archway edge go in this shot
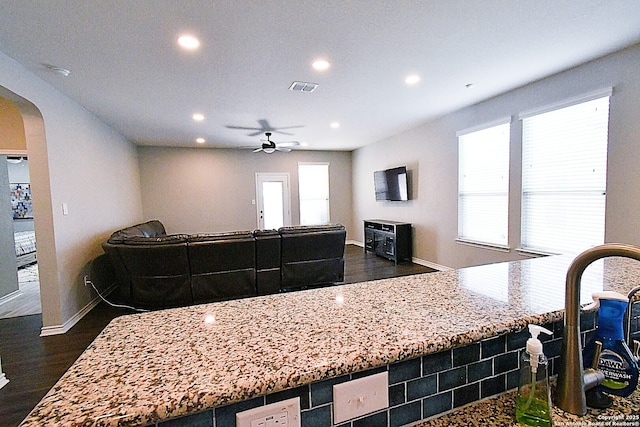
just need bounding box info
[0,53,142,333]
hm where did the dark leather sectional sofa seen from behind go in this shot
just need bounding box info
[102,220,346,310]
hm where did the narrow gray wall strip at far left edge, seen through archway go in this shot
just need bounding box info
[0,156,18,298]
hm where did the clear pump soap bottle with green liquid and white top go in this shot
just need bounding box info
[516,325,553,427]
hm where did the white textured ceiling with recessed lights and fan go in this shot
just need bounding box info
[0,0,640,150]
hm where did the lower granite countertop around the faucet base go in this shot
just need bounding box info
[412,389,640,427]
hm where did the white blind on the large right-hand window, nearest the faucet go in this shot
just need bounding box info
[521,96,609,253]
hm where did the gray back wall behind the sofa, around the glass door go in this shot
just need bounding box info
[138,147,352,233]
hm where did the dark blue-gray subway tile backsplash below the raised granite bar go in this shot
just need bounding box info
[145,308,640,427]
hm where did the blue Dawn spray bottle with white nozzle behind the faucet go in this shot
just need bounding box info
[583,291,638,397]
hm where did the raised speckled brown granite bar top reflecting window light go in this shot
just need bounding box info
[22,256,640,426]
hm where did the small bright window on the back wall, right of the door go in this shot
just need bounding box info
[298,163,329,225]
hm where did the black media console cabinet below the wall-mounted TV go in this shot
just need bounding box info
[364,219,412,264]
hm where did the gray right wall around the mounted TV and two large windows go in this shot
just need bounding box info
[353,45,640,268]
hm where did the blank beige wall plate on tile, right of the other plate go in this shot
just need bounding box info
[333,372,389,424]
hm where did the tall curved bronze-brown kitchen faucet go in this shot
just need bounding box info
[555,243,640,415]
